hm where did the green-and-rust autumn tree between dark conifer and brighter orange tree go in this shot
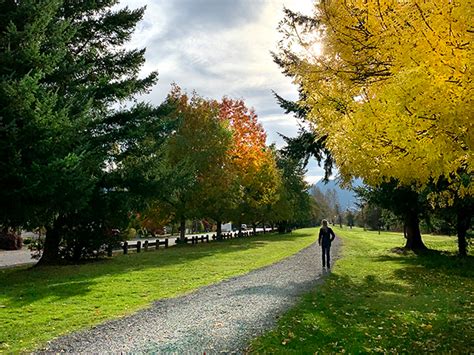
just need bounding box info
[160,86,232,239]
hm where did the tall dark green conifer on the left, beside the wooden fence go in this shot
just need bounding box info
[0,0,166,263]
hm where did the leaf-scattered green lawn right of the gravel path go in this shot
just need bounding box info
[251,228,474,354]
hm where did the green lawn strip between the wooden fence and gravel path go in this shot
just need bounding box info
[0,229,315,352]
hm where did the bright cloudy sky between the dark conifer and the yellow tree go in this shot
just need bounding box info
[119,0,324,183]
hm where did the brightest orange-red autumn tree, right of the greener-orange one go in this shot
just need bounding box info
[220,98,281,234]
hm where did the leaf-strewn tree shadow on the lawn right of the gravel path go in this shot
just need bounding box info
[260,268,472,353]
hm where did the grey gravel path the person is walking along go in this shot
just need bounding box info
[44,238,340,354]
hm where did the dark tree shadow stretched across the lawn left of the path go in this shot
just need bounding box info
[0,233,308,309]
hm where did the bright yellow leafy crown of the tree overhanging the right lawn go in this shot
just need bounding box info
[280,0,474,250]
